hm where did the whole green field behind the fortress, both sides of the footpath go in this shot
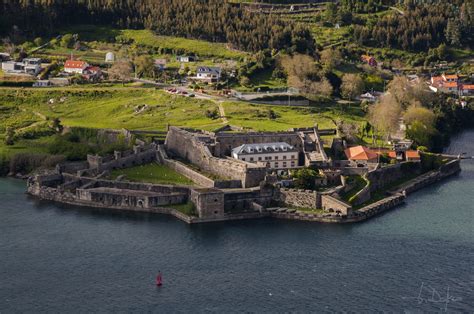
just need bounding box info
[0,85,365,155]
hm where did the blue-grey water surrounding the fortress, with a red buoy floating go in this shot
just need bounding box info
[0,132,474,313]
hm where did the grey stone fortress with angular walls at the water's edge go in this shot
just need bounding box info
[28,127,460,223]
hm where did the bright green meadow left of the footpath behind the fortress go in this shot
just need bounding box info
[0,88,222,134]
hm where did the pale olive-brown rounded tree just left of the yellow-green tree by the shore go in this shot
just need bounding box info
[369,94,402,137]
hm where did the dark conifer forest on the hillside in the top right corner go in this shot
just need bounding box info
[354,0,474,51]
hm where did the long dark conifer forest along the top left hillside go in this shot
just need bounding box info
[0,0,315,53]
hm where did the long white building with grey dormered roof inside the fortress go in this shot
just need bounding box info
[232,142,299,169]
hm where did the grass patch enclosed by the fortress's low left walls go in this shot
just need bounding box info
[110,163,194,185]
